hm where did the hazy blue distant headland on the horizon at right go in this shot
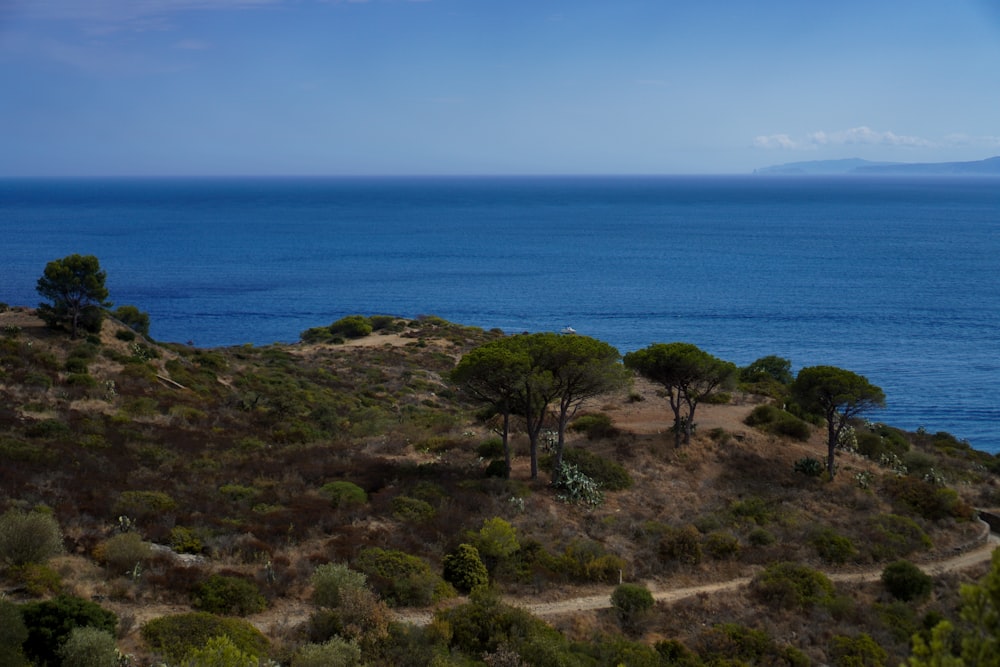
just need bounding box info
[753,156,1000,176]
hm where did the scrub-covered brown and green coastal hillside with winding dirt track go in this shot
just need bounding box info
[0,307,1000,667]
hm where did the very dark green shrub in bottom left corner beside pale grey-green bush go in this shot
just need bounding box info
[21,595,118,665]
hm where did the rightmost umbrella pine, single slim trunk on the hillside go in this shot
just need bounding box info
[791,366,885,479]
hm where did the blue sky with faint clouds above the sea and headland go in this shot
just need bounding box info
[0,0,1000,176]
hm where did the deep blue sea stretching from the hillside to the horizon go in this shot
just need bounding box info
[0,176,1000,452]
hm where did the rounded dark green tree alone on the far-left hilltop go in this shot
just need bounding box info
[36,254,111,338]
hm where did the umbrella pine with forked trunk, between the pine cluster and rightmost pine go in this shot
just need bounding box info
[625,343,736,445]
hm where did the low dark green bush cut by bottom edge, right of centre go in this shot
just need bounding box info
[697,623,810,667]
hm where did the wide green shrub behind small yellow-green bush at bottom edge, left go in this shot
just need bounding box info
[141,611,269,662]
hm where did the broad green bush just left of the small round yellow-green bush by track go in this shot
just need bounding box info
[354,547,454,607]
